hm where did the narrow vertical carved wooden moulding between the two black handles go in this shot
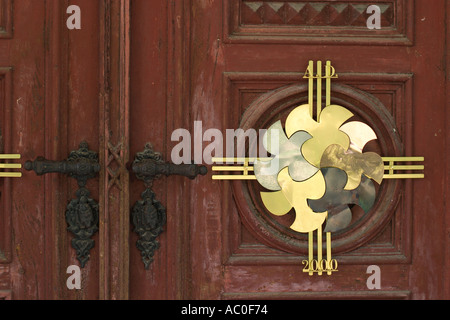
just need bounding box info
[99,0,130,300]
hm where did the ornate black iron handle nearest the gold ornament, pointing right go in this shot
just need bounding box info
[131,144,208,270]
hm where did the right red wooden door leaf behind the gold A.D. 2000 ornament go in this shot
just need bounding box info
[130,0,448,299]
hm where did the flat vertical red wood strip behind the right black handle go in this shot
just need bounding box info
[130,1,174,299]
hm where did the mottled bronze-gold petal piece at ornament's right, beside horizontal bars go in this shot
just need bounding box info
[320,144,384,190]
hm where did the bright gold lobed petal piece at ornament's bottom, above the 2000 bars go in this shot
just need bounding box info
[278,168,327,233]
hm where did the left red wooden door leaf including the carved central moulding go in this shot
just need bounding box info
[0,0,129,299]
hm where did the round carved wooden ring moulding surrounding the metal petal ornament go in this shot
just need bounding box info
[232,84,403,255]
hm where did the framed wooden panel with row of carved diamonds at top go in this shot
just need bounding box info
[229,0,415,46]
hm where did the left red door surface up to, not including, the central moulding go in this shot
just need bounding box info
[0,0,104,300]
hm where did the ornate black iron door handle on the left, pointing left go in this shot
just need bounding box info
[25,141,100,268]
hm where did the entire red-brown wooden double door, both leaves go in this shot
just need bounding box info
[0,0,450,299]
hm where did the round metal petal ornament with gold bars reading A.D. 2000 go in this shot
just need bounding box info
[213,61,424,275]
